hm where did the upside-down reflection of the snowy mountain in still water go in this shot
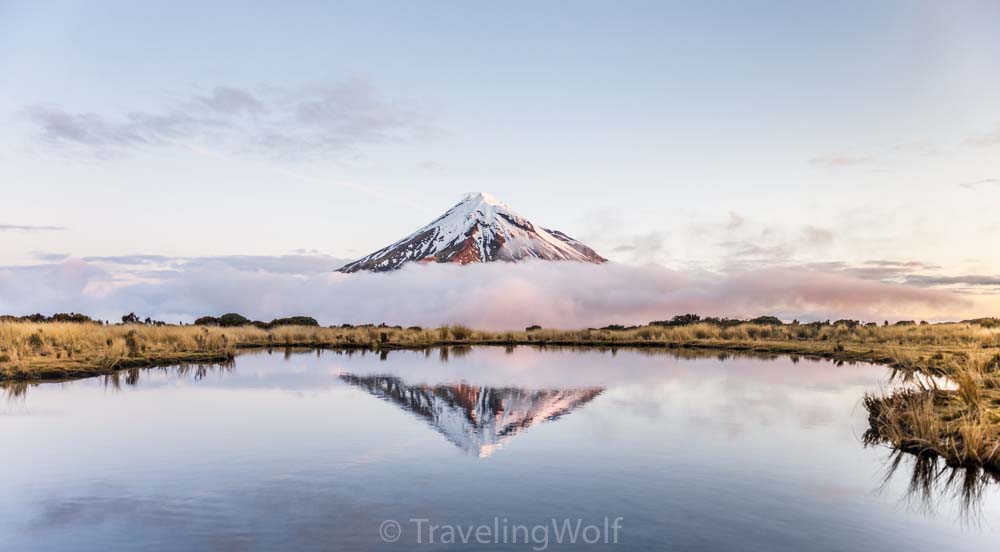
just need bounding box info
[340,374,604,458]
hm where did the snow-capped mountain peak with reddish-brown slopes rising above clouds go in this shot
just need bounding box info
[338,192,607,272]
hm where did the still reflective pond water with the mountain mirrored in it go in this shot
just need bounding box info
[0,347,1000,551]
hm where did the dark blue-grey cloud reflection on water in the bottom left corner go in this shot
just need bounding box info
[27,478,395,550]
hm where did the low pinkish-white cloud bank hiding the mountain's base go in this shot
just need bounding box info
[0,256,972,329]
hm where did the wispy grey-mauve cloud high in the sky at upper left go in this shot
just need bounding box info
[23,79,436,159]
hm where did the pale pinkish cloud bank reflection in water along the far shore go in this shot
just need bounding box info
[7,346,887,446]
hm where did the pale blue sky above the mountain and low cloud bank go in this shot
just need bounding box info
[0,0,1000,320]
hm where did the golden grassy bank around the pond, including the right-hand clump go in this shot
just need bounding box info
[0,321,1000,470]
